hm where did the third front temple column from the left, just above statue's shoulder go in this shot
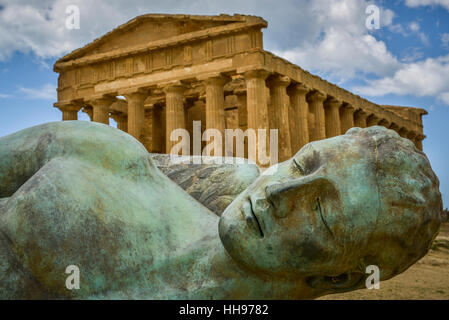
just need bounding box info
[124,92,147,141]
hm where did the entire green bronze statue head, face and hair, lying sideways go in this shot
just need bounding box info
[219,127,442,293]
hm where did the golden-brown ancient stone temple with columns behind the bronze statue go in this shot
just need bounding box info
[54,14,427,161]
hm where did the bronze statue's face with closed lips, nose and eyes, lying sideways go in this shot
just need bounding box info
[219,135,378,277]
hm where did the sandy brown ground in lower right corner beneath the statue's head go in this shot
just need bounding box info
[319,223,449,300]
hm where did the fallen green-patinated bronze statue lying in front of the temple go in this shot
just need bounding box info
[0,121,442,299]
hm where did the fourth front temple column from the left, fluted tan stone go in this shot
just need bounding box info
[164,83,186,153]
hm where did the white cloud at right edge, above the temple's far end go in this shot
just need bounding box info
[354,55,449,105]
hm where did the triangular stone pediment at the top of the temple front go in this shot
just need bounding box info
[56,14,267,64]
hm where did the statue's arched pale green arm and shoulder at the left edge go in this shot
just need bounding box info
[0,121,152,199]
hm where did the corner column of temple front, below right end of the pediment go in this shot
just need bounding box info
[244,70,270,167]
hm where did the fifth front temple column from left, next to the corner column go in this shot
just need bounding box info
[204,76,230,147]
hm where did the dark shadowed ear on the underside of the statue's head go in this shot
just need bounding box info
[306,272,365,292]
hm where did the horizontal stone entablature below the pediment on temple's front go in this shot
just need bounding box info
[54,15,267,101]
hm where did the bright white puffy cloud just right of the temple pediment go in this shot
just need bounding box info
[276,1,400,81]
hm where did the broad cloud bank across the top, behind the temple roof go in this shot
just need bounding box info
[0,0,398,78]
